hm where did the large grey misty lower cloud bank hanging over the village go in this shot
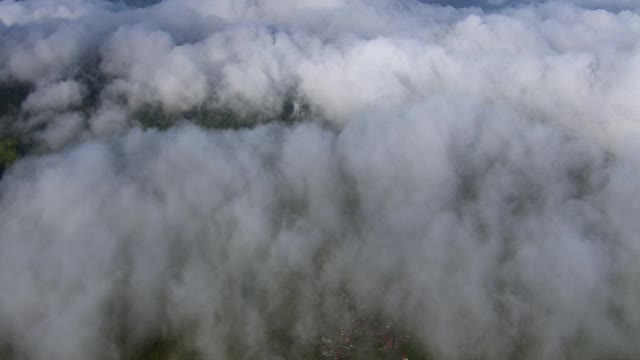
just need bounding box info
[0,97,640,359]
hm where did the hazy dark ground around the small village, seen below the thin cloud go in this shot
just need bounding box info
[0,292,432,360]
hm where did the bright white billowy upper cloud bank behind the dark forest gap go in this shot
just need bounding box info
[0,0,639,132]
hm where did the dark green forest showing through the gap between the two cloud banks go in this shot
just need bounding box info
[0,65,311,179]
